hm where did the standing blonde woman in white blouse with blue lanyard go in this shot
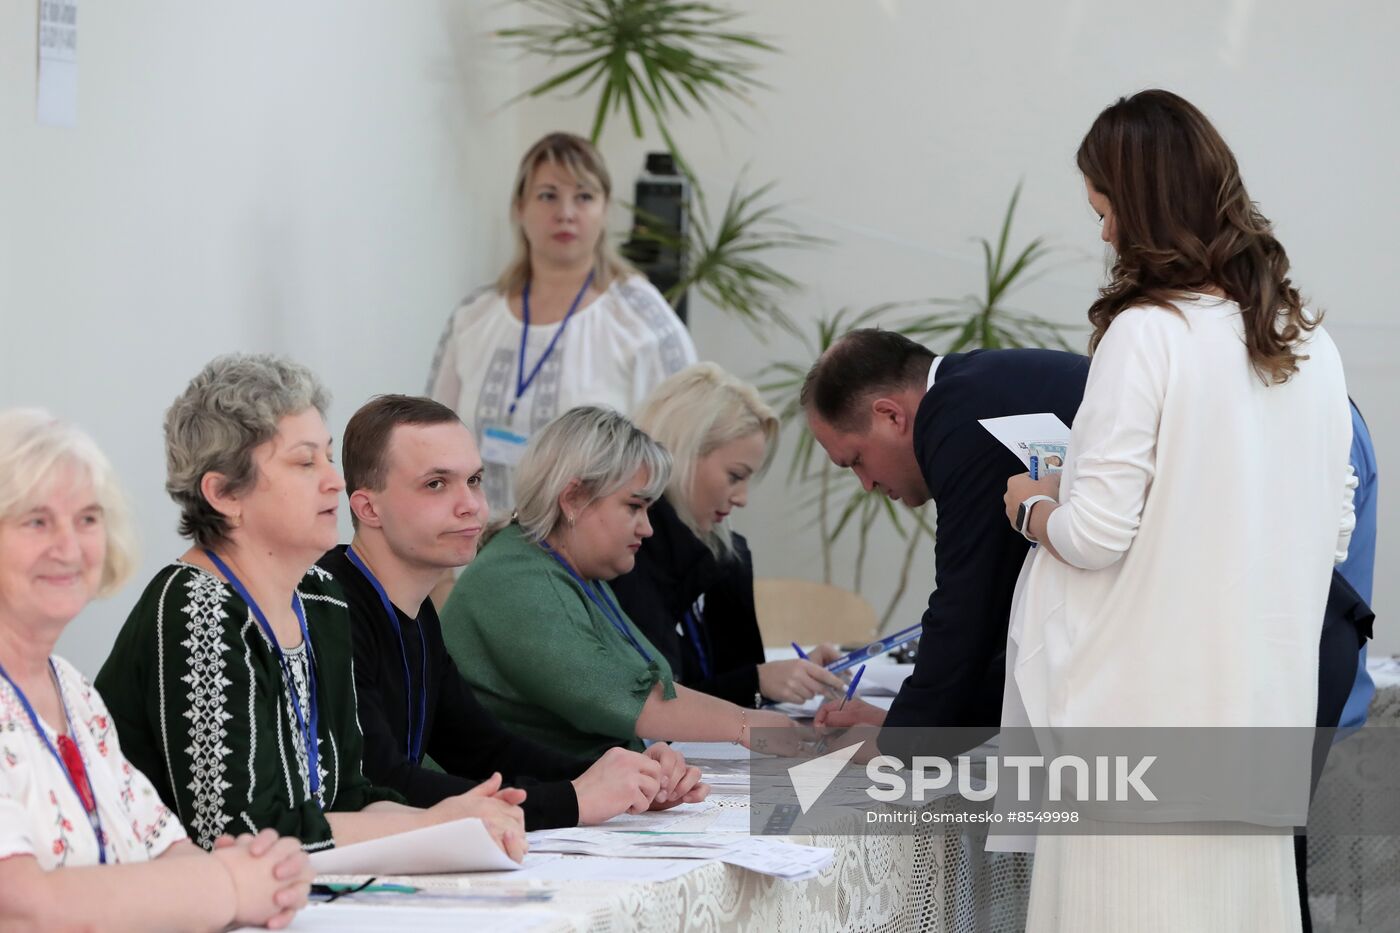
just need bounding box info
[428,133,696,516]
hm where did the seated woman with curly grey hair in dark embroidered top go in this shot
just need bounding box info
[97,354,525,859]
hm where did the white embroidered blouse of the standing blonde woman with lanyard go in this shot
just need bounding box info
[428,276,696,516]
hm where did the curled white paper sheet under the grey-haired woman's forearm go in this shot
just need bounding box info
[311,818,519,876]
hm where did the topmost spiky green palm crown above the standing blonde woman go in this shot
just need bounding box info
[497,0,777,153]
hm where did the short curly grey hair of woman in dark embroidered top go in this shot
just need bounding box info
[165,353,330,548]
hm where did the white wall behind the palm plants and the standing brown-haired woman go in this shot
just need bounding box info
[522,0,1400,651]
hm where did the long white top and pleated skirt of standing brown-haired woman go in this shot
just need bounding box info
[1008,296,1354,933]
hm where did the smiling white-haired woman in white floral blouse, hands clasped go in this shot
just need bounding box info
[0,409,311,930]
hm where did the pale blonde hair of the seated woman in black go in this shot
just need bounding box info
[637,363,781,556]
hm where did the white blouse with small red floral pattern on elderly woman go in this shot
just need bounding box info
[0,657,185,870]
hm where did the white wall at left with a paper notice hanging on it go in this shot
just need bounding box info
[0,0,518,674]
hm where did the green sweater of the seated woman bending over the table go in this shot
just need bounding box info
[442,524,676,758]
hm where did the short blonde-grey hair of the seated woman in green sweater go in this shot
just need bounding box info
[515,405,671,542]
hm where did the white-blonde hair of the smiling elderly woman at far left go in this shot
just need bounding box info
[0,408,137,595]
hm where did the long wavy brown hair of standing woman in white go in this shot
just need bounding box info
[1075,90,1322,384]
